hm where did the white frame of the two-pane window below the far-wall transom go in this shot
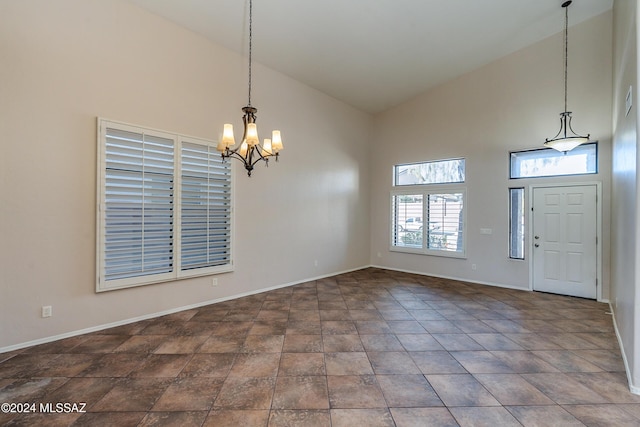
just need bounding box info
[389,184,467,259]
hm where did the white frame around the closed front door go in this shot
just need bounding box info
[525,181,606,302]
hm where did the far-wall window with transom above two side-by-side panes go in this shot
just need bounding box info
[391,159,466,257]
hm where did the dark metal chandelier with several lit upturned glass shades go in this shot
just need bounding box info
[216,0,283,176]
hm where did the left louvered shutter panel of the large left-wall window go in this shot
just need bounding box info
[104,128,174,280]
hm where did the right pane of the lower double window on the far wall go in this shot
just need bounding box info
[427,193,464,252]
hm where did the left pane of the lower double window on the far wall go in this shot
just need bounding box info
[392,194,424,249]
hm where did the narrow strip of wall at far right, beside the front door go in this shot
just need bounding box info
[611,0,640,393]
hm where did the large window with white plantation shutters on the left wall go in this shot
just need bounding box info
[96,119,232,291]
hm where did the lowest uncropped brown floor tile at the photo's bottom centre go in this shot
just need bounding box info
[271,376,329,409]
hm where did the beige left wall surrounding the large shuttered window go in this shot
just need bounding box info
[0,0,372,351]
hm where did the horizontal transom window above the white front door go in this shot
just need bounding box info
[510,143,598,178]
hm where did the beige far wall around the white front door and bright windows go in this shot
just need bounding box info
[371,12,612,299]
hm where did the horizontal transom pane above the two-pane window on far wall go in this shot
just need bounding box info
[394,159,465,185]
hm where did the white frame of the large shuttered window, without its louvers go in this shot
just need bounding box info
[96,118,235,292]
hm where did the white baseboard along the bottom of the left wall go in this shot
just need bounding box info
[0,265,371,354]
